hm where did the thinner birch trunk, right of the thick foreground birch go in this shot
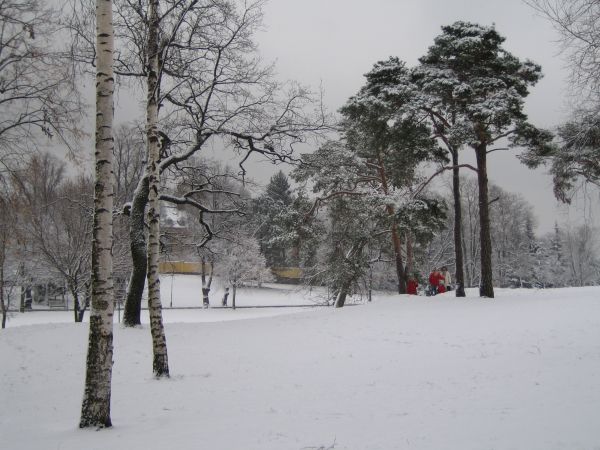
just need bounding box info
[146,0,169,377]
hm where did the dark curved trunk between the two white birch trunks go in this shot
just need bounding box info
[123,176,149,327]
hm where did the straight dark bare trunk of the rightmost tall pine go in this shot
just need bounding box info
[475,144,494,298]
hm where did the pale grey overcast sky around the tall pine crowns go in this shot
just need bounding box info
[248,0,598,232]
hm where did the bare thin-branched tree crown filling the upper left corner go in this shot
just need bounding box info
[0,0,82,167]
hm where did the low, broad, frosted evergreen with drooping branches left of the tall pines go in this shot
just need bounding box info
[292,141,437,306]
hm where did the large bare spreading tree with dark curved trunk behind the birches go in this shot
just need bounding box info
[71,0,328,325]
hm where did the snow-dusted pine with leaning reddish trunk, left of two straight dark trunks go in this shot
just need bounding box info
[340,58,441,293]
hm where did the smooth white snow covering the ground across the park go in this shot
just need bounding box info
[0,276,600,450]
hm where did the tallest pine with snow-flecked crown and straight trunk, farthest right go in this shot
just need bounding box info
[420,22,547,297]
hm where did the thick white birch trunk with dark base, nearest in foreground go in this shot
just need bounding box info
[79,0,114,428]
